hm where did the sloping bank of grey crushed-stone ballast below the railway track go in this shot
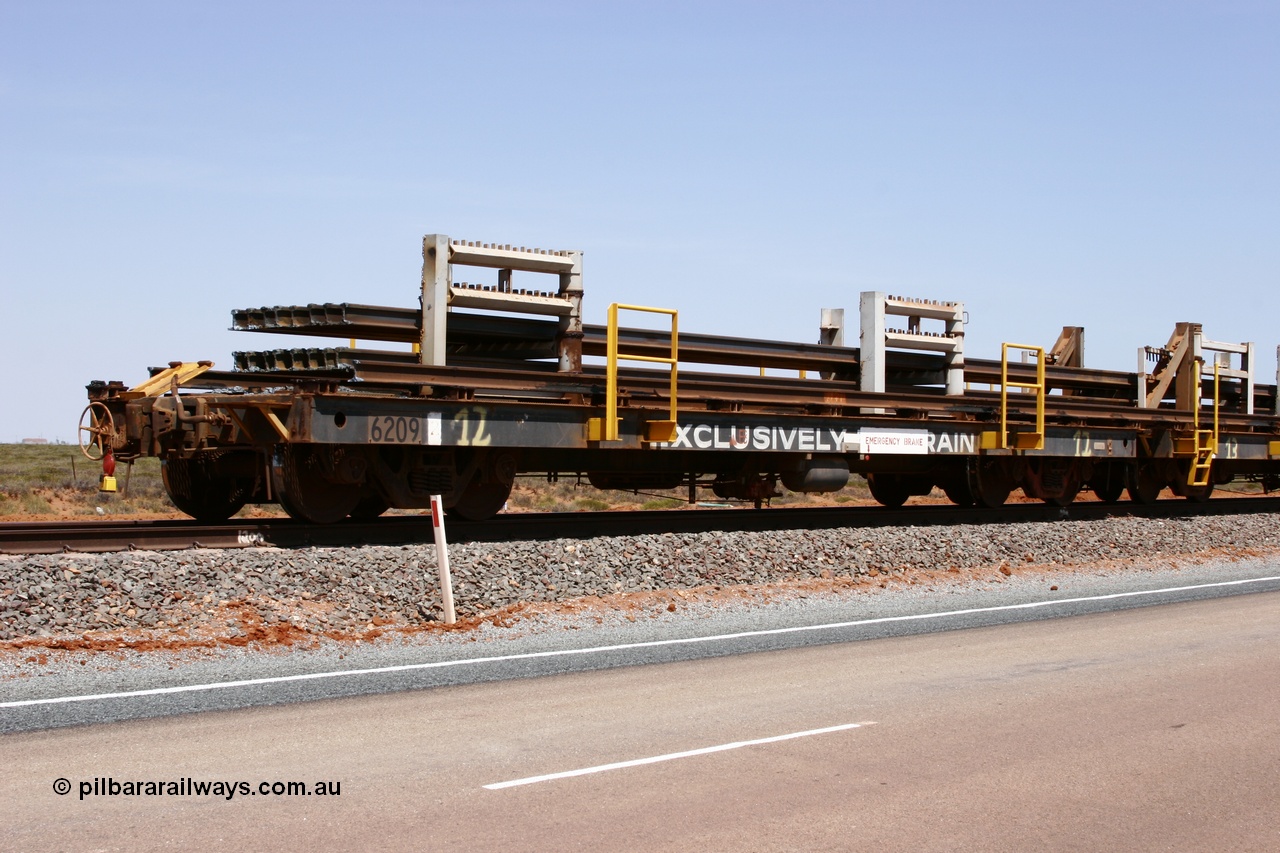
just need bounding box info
[0,514,1280,646]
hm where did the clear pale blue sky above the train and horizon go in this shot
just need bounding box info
[0,0,1280,441]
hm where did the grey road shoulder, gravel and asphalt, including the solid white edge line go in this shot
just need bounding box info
[0,550,1280,733]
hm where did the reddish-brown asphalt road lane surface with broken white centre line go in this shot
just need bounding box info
[0,592,1280,852]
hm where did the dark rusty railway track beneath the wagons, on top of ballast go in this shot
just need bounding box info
[0,497,1280,555]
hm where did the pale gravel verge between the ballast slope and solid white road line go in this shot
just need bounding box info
[0,540,1280,731]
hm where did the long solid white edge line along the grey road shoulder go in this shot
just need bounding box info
[0,575,1280,708]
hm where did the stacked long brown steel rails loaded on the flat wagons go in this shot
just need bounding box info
[198,302,1276,429]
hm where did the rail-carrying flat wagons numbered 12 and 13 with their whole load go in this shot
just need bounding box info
[79,234,1280,524]
